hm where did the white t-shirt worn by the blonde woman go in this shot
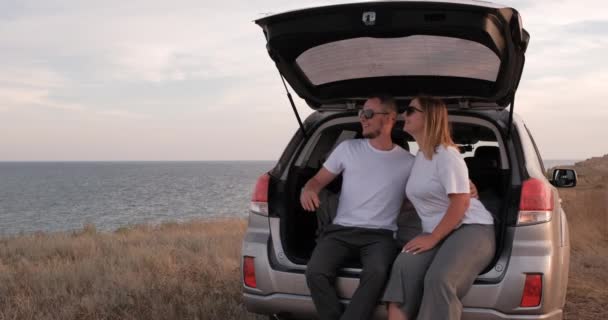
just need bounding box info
[405,146,494,233]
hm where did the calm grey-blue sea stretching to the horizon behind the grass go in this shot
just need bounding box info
[0,160,577,236]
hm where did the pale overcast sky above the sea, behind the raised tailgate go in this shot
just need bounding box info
[0,0,608,161]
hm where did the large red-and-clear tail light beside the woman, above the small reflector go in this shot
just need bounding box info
[517,178,553,225]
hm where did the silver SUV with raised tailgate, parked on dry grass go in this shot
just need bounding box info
[241,1,576,319]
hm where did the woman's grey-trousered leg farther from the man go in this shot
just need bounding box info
[417,224,495,320]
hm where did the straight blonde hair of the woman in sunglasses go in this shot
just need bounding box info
[415,95,456,160]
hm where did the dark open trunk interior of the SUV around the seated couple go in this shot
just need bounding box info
[281,116,511,269]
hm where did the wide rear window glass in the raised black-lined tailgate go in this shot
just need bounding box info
[296,35,500,85]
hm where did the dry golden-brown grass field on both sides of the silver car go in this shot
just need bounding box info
[0,156,608,320]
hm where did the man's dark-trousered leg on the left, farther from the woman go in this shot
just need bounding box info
[306,230,353,320]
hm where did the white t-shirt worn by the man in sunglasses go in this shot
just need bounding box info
[323,139,414,231]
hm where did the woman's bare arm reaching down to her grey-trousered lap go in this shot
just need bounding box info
[402,193,471,254]
